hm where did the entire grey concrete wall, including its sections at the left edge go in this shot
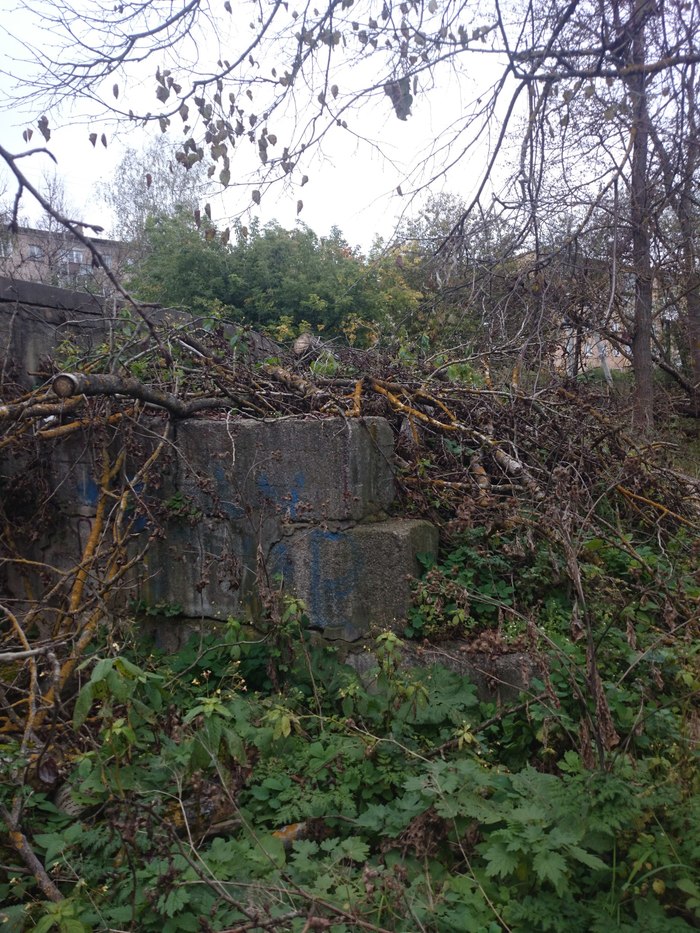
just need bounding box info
[0,280,438,640]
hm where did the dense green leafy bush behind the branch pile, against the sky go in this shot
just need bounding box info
[127,212,419,344]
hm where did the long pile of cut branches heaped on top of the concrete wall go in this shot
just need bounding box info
[5,314,700,529]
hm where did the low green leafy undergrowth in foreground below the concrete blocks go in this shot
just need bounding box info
[0,576,700,933]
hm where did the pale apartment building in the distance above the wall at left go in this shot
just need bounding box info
[0,224,131,295]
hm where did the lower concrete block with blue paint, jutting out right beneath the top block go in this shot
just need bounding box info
[270,519,438,641]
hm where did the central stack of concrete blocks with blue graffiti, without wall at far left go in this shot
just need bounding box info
[138,418,437,640]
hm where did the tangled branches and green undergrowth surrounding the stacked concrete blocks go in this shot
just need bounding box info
[0,310,700,933]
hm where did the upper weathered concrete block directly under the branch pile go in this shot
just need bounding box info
[176,418,395,524]
